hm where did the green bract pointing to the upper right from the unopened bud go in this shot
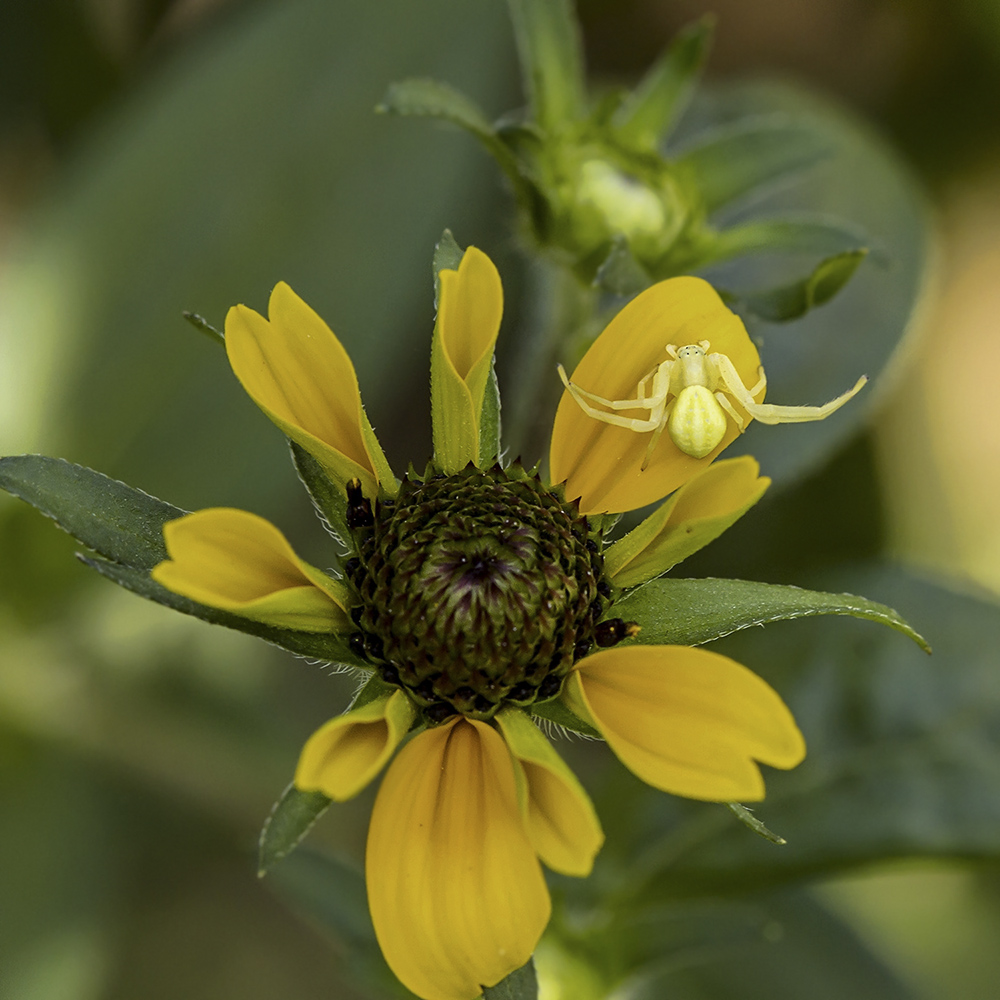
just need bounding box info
[612,14,715,149]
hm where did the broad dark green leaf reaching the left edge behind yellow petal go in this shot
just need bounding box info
[0,455,186,570]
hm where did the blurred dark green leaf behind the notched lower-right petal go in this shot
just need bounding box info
[600,569,1000,902]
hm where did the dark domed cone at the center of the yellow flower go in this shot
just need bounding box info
[347,465,621,721]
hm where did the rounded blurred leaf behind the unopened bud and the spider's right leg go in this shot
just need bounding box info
[674,83,931,491]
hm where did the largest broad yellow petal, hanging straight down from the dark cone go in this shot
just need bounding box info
[365,718,550,1000]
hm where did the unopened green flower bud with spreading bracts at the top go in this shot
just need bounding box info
[379,0,868,312]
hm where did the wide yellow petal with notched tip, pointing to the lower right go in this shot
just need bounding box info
[564,646,806,802]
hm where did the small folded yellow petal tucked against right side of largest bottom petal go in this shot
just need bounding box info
[496,708,604,877]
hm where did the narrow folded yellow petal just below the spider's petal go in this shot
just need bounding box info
[604,455,771,587]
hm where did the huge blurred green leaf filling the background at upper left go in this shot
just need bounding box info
[0,0,516,517]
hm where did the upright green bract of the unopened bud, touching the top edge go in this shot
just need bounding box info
[507,0,586,132]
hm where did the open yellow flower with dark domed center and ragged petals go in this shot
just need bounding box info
[153,248,805,1000]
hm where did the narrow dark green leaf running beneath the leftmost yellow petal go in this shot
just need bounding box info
[78,555,371,671]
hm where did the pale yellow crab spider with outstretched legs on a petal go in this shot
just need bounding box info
[559,340,868,469]
